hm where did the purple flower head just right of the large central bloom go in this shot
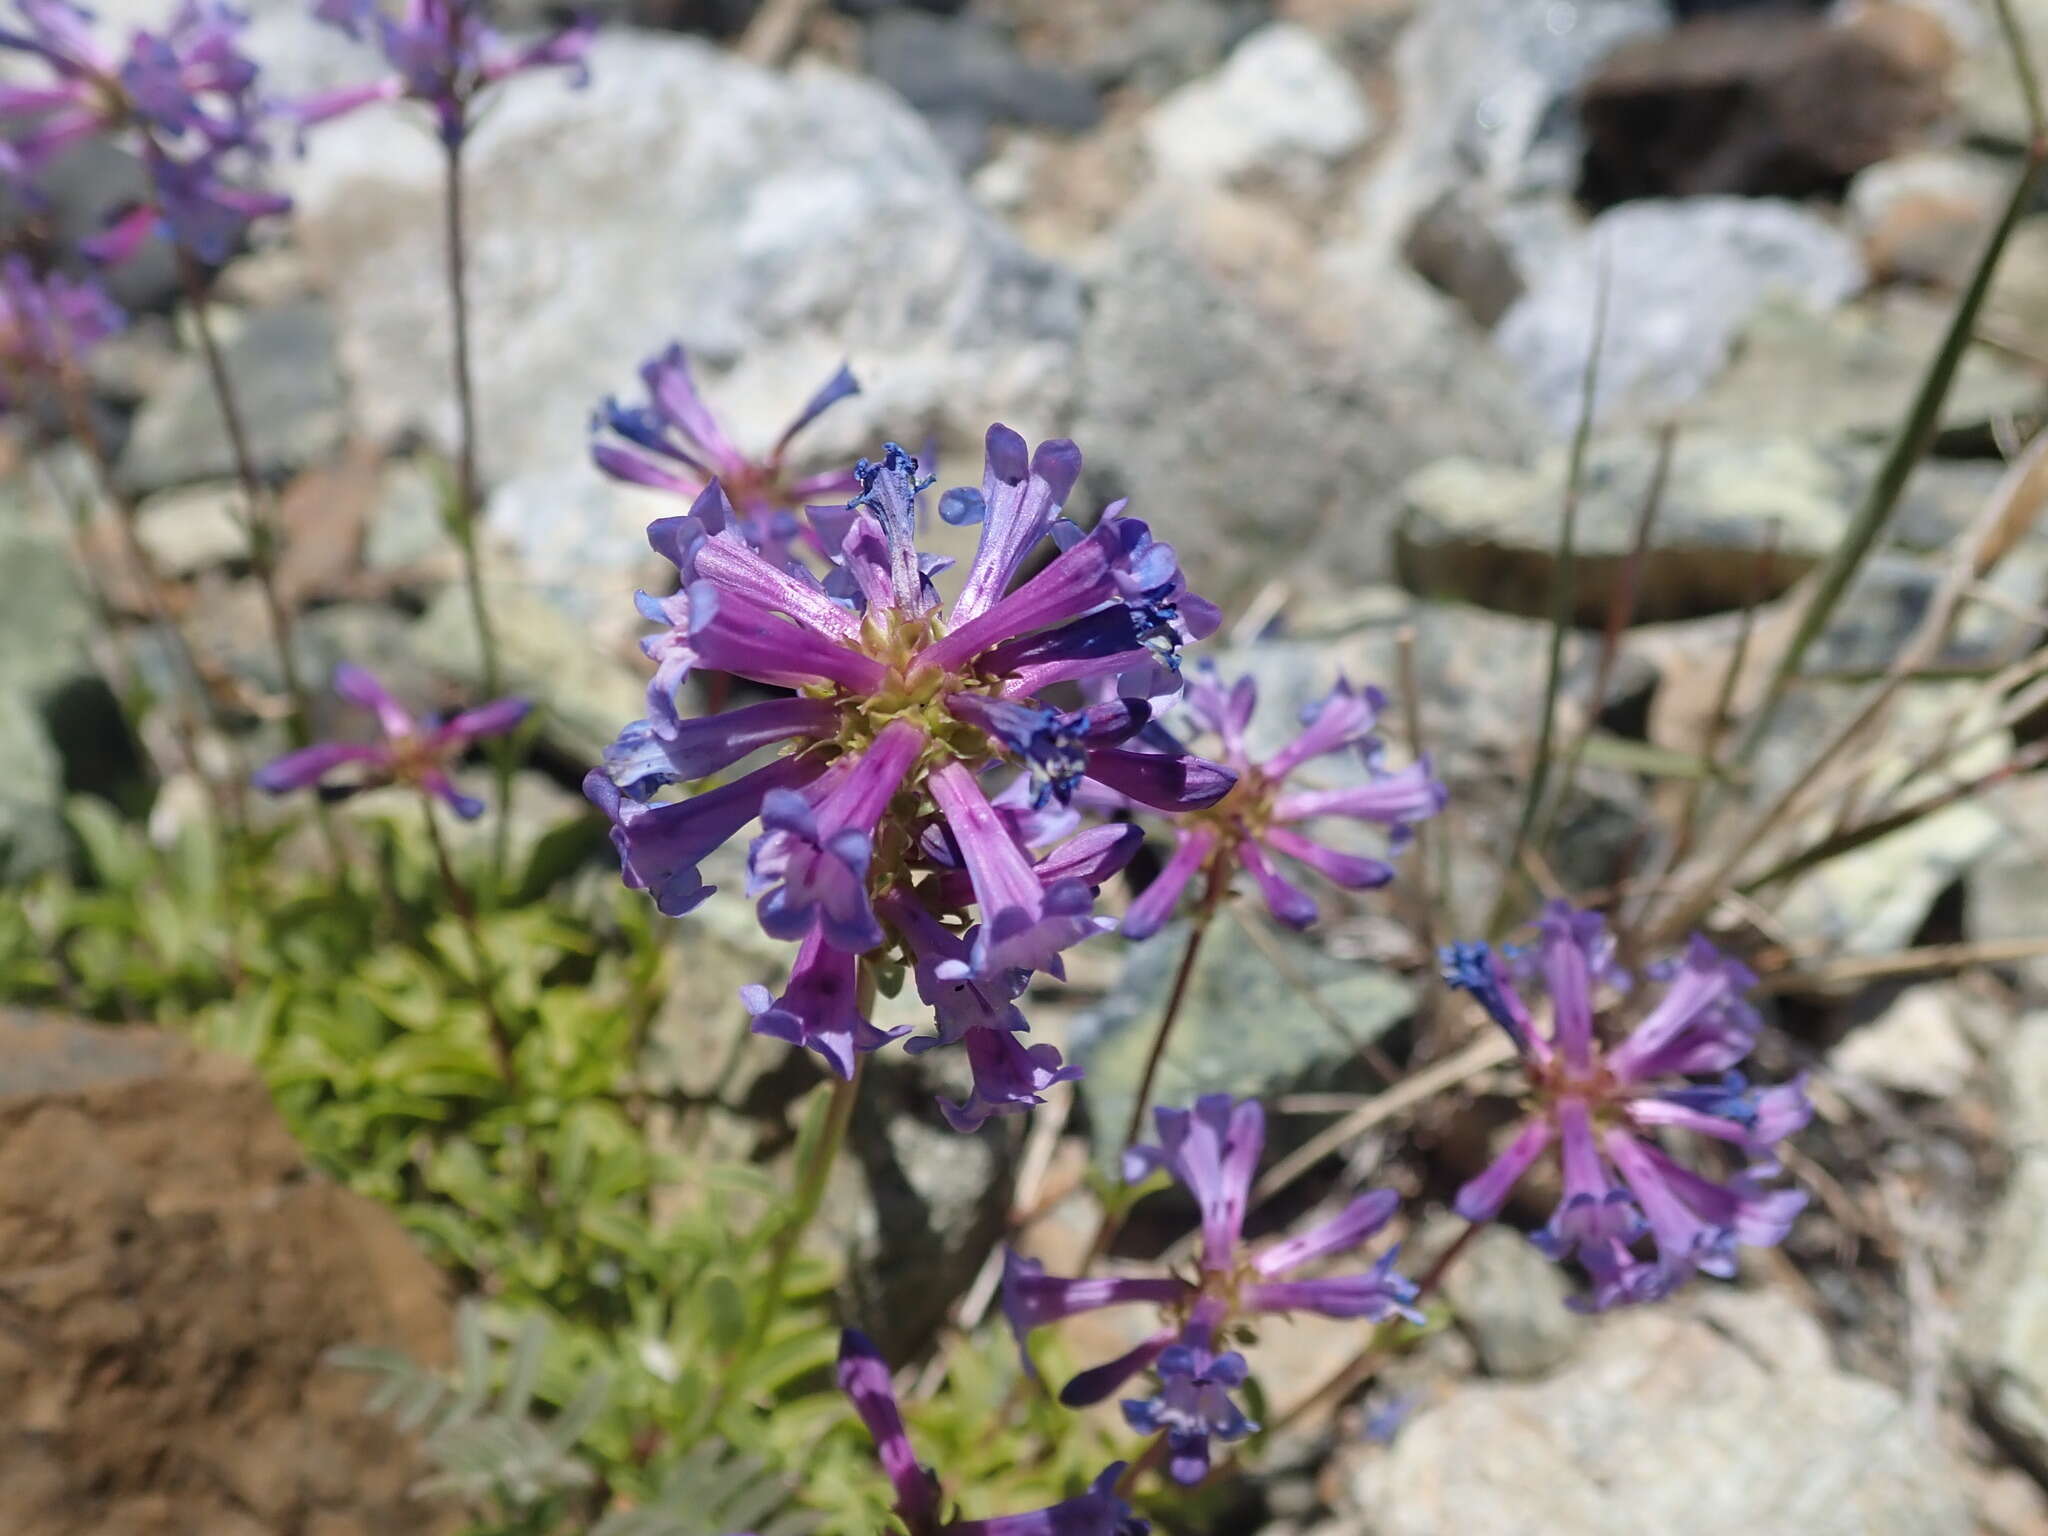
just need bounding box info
[1122,668,1444,938]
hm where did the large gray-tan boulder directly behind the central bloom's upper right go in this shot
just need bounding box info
[1073,193,1536,604]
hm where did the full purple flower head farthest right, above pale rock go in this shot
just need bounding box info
[1444,903,1812,1311]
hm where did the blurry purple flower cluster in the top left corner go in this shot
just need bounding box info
[0,0,291,262]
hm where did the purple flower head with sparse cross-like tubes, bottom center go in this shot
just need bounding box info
[1004,1094,1419,1483]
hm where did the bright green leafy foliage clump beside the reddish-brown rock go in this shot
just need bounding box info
[0,801,1120,1536]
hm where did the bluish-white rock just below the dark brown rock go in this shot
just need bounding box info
[1493,197,1864,432]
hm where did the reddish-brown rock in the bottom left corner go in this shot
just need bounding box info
[0,1014,453,1536]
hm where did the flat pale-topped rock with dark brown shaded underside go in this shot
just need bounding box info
[1399,432,1851,625]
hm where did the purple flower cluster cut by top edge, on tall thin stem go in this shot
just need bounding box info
[293,0,592,145]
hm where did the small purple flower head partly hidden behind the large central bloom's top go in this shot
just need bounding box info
[590,342,860,565]
